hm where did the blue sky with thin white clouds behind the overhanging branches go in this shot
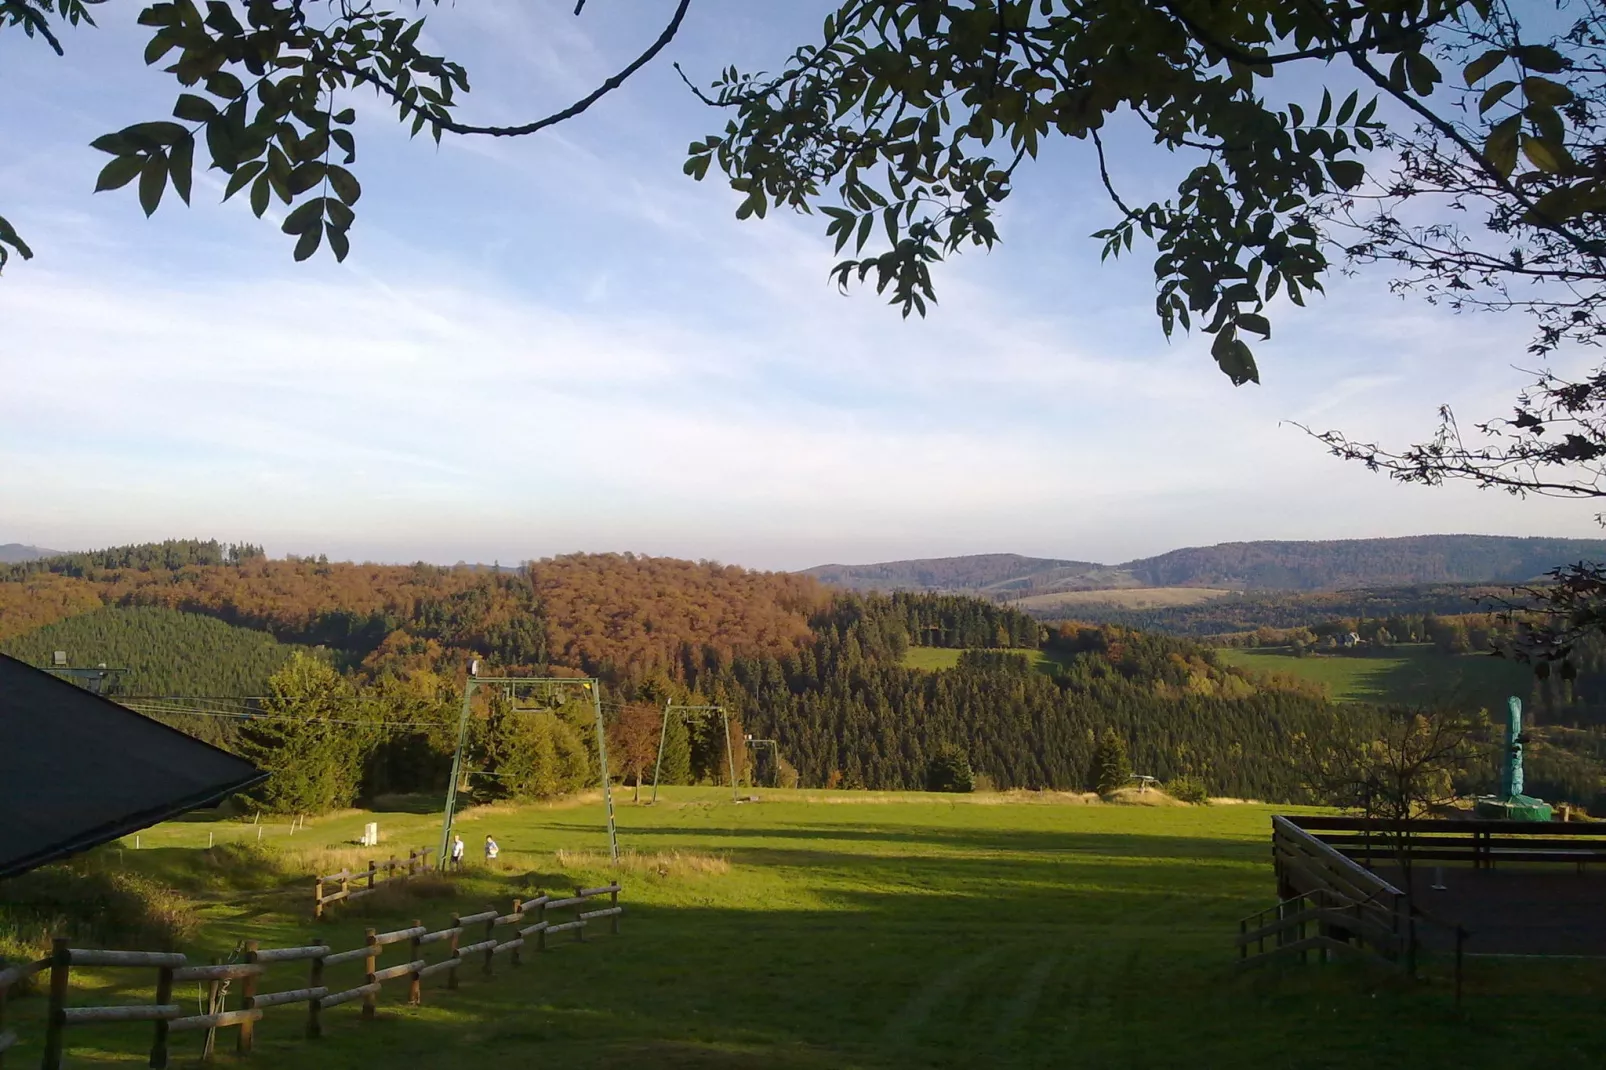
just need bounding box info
[0,0,1600,569]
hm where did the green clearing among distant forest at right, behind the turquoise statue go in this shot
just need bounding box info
[1216,644,1532,710]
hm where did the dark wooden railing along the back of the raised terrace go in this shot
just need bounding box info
[1277,816,1606,872]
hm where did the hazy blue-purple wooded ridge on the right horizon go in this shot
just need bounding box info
[805,535,1606,598]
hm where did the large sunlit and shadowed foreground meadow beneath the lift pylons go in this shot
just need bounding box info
[11,789,1606,1070]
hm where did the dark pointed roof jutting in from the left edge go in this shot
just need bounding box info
[0,654,267,877]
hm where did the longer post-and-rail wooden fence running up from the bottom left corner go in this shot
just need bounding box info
[0,884,625,1070]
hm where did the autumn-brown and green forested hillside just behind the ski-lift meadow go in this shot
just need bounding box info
[0,546,1335,805]
